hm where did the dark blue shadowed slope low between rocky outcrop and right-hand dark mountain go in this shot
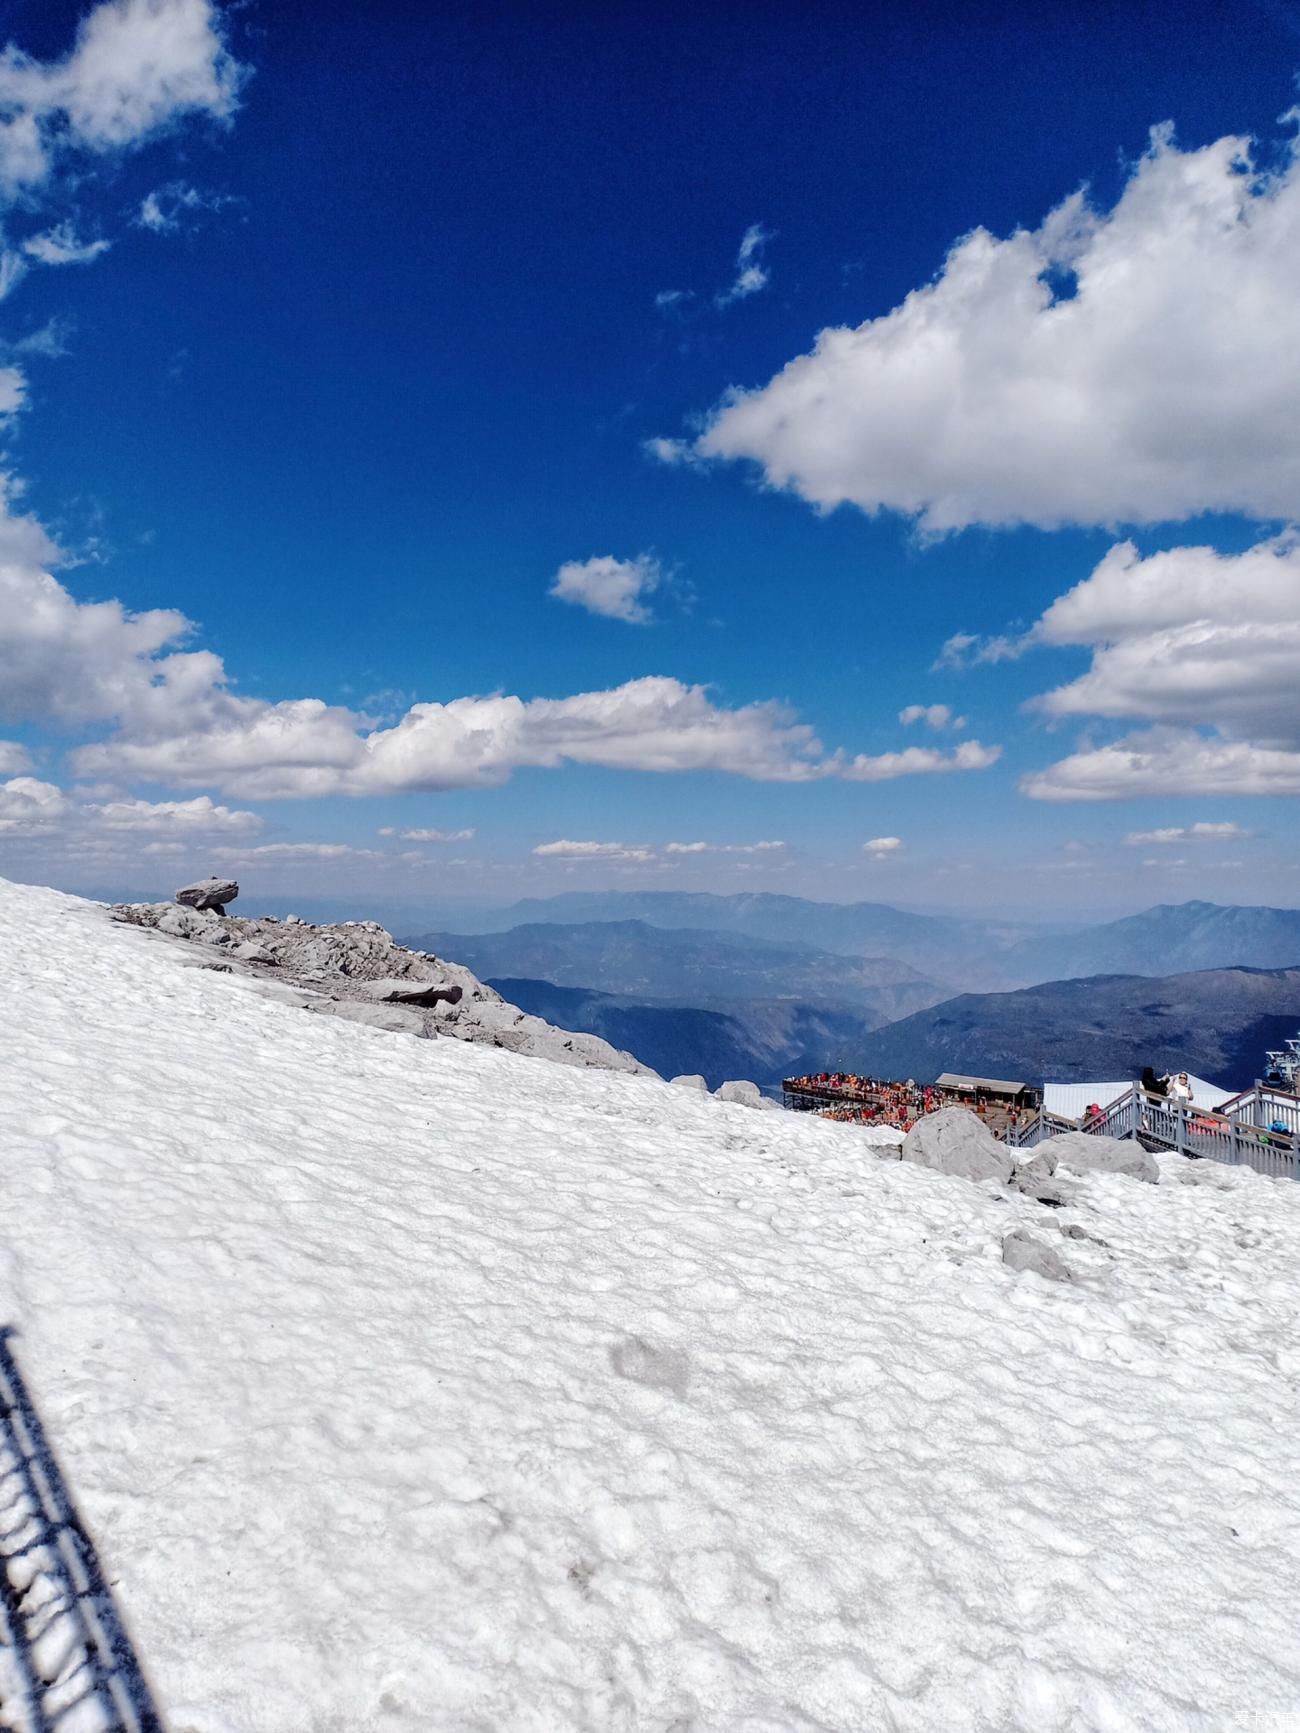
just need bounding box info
[487,976,868,1090]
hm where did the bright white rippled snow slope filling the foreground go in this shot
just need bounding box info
[0,882,1300,1733]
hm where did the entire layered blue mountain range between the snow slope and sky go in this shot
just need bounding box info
[406,891,1300,1085]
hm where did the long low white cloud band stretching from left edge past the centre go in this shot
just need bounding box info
[0,496,1000,799]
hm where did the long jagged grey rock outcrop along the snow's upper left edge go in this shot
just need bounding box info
[113,903,655,1076]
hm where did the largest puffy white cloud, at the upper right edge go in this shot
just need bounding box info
[666,127,1300,532]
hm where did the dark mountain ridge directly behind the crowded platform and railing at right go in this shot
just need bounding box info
[837,967,1300,1088]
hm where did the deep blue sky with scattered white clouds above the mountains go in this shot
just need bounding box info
[0,0,1300,913]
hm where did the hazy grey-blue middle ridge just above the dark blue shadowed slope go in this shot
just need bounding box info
[406,920,952,1028]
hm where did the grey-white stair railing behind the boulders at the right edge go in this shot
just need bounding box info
[1007,1083,1300,1178]
